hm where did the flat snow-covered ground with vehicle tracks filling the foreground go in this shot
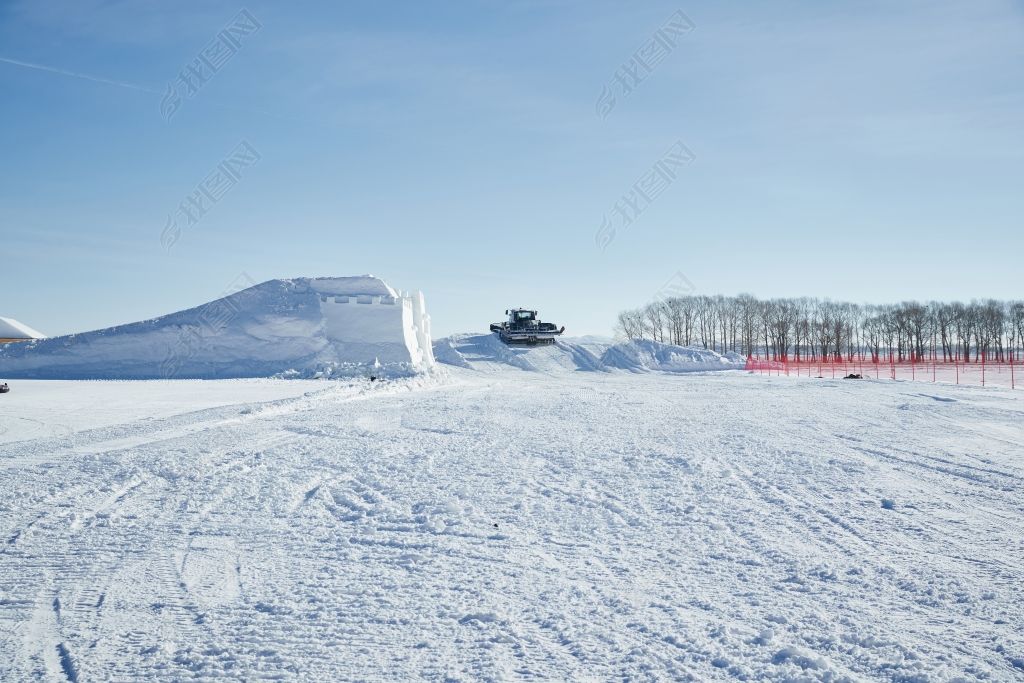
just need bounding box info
[0,368,1024,681]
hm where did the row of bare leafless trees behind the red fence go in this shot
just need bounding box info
[616,294,1024,361]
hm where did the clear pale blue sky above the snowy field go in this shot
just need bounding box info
[0,0,1024,336]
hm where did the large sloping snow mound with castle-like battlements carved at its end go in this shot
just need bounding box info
[0,275,434,379]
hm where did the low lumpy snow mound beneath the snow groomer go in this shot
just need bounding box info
[434,334,745,373]
